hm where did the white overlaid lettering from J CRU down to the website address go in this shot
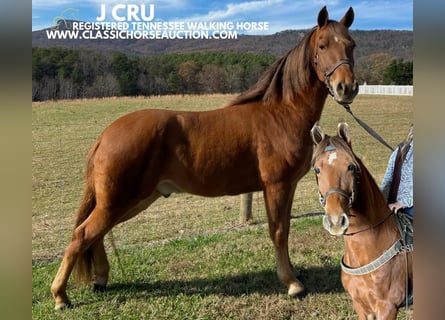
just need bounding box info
[46,4,269,40]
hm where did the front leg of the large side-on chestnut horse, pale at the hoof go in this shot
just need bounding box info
[264,183,304,296]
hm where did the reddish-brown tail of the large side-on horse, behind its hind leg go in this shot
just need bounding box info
[73,140,99,284]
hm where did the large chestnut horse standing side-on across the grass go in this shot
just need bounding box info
[51,7,358,309]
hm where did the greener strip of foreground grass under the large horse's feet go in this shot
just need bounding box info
[33,217,351,319]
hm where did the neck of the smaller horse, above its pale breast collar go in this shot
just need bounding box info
[343,159,399,266]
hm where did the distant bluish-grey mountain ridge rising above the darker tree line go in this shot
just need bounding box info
[32,22,413,60]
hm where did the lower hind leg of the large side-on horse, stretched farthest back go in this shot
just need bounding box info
[51,206,113,309]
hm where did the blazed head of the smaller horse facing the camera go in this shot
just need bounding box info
[311,122,360,235]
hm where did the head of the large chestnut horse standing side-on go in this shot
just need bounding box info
[311,7,359,104]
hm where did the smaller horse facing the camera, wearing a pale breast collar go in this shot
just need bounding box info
[311,123,413,320]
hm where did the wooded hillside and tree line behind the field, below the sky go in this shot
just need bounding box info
[32,24,413,101]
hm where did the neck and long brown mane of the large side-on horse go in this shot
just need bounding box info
[229,31,328,131]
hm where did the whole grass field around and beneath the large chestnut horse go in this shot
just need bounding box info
[32,95,413,319]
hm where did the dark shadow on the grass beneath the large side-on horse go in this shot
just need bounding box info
[107,266,343,298]
